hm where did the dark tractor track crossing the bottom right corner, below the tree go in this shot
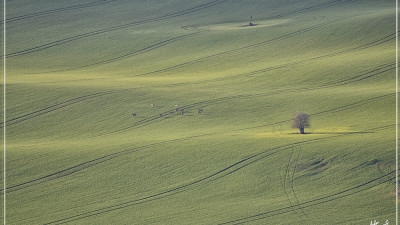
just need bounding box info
[219,171,396,225]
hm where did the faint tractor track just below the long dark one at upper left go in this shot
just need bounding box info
[46,31,205,73]
